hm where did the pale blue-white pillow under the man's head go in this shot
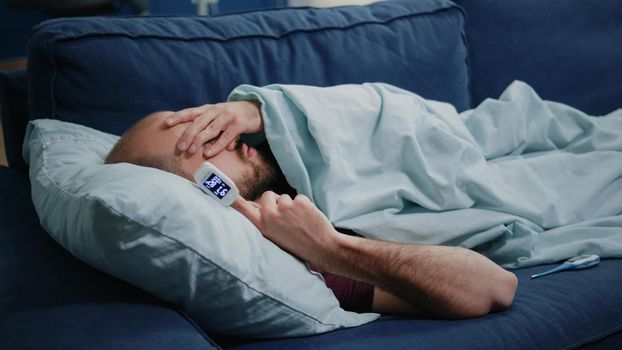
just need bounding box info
[24,119,378,337]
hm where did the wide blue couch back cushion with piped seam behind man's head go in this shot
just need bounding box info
[28,0,469,134]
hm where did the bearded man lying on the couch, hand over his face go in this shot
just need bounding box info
[106,101,517,318]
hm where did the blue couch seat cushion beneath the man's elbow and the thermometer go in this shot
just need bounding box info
[215,259,622,350]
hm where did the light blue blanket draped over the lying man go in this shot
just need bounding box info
[230,82,622,267]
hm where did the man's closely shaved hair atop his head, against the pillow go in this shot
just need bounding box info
[105,112,188,178]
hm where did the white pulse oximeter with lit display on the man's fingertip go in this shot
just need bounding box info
[194,162,240,207]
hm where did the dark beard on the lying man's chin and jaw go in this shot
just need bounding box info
[238,141,283,201]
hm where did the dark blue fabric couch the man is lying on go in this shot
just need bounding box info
[0,0,622,349]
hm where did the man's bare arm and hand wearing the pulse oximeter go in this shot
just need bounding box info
[234,192,517,318]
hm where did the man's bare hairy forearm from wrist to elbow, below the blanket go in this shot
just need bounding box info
[318,234,517,318]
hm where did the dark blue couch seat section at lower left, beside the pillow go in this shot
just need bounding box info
[0,167,216,349]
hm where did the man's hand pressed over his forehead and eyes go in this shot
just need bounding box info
[166,101,263,157]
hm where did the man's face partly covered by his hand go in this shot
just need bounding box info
[139,112,277,200]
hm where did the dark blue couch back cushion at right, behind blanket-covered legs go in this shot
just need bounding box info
[456,0,622,115]
